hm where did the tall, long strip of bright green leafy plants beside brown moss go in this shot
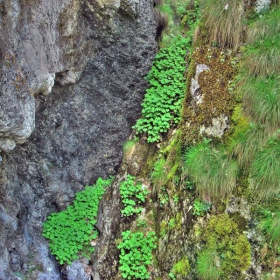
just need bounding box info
[133,1,201,143]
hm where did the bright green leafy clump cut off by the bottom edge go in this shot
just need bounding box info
[118,230,157,279]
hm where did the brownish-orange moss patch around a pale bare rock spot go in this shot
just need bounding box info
[182,47,236,146]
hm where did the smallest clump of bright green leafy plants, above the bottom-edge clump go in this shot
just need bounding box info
[120,174,149,217]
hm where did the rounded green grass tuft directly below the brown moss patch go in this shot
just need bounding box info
[184,139,238,197]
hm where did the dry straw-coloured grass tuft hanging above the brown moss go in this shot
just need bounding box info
[203,0,244,50]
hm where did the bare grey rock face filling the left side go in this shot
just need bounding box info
[0,0,158,280]
